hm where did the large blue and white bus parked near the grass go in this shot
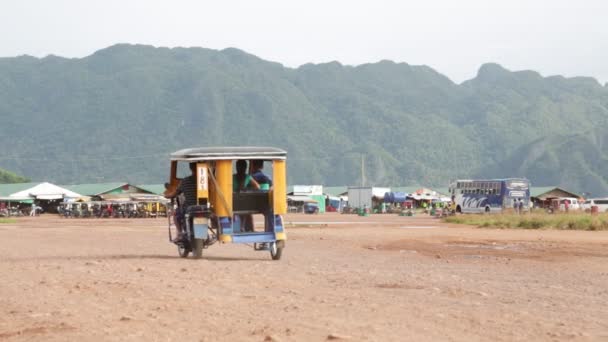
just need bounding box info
[449,178,530,213]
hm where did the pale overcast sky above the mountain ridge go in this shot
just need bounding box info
[0,0,608,83]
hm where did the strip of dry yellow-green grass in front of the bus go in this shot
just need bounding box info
[443,213,608,230]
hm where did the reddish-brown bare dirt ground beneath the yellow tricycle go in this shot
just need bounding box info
[0,213,608,341]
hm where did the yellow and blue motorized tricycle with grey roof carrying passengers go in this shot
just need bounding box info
[165,146,287,260]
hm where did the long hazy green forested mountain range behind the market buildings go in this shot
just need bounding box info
[0,45,608,195]
